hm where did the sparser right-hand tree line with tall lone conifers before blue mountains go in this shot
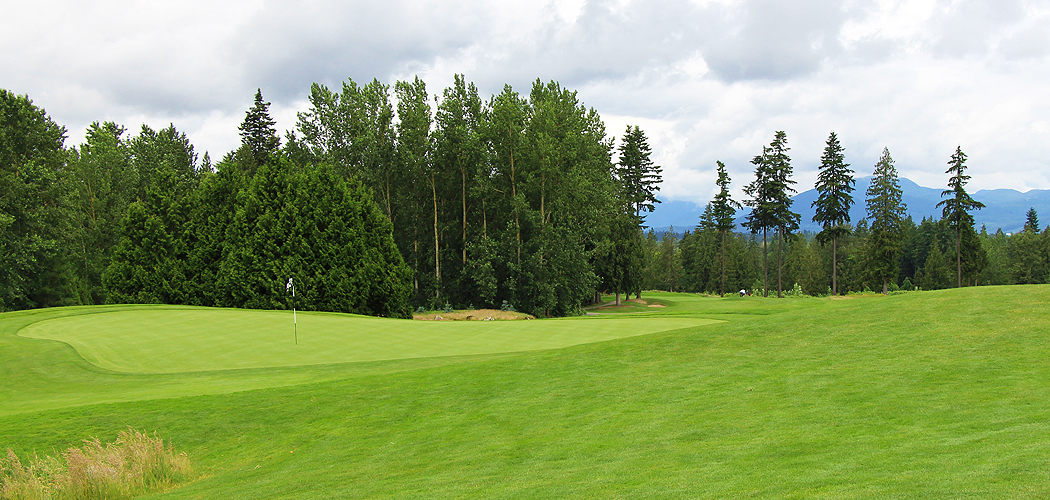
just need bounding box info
[643,131,1050,296]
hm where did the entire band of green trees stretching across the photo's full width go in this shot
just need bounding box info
[0,76,1050,317]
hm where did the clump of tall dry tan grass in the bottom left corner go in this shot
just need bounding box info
[0,428,192,500]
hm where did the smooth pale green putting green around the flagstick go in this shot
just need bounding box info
[19,306,718,373]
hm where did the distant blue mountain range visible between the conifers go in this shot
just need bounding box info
[646,176,1050,233]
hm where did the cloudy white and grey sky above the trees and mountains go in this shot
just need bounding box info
[0,0,1050,203]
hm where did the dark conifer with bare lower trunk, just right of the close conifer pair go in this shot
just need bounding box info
[813,131,856,295]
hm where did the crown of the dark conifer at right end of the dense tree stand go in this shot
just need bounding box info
[616,125,663,223]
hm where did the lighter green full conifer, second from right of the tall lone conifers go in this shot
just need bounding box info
[866,148,906,294]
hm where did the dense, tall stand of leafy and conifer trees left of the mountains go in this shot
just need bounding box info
[0,76,660,317]
